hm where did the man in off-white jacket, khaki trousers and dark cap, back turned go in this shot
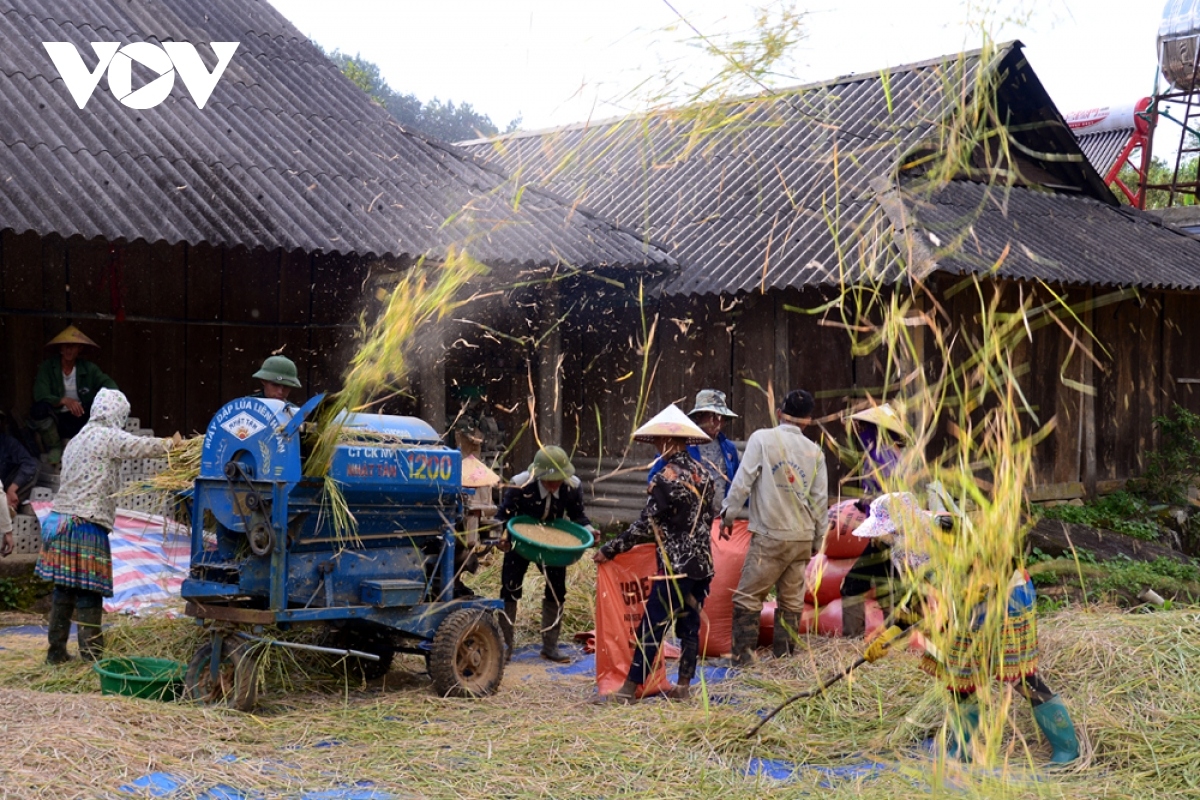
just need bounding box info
[721,390,829,666]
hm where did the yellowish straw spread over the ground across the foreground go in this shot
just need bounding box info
[0,604,1200,800]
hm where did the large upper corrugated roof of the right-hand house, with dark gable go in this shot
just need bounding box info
[461,42,1161,294]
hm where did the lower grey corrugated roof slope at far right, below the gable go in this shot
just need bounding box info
[905,181,1200,289]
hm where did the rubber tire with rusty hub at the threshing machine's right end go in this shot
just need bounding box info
[428,608,504,697]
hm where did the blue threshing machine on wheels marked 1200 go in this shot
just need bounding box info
[182,397,504,710]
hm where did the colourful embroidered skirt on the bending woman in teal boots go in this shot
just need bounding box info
[920,571,1038,694]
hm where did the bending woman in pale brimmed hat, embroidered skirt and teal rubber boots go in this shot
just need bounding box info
[854,492,1079,764]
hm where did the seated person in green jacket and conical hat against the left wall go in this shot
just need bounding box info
[29,325,116,464]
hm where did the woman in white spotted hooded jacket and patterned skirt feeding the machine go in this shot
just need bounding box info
[35,389,180,664]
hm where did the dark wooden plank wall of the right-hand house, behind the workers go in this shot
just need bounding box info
[554,281,1200,485]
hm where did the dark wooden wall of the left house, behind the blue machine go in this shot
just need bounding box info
[0,231,368,433]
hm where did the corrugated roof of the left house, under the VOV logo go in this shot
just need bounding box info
[0,0,670,267]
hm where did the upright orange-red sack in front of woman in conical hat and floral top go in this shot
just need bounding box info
[596,545,672,697]
